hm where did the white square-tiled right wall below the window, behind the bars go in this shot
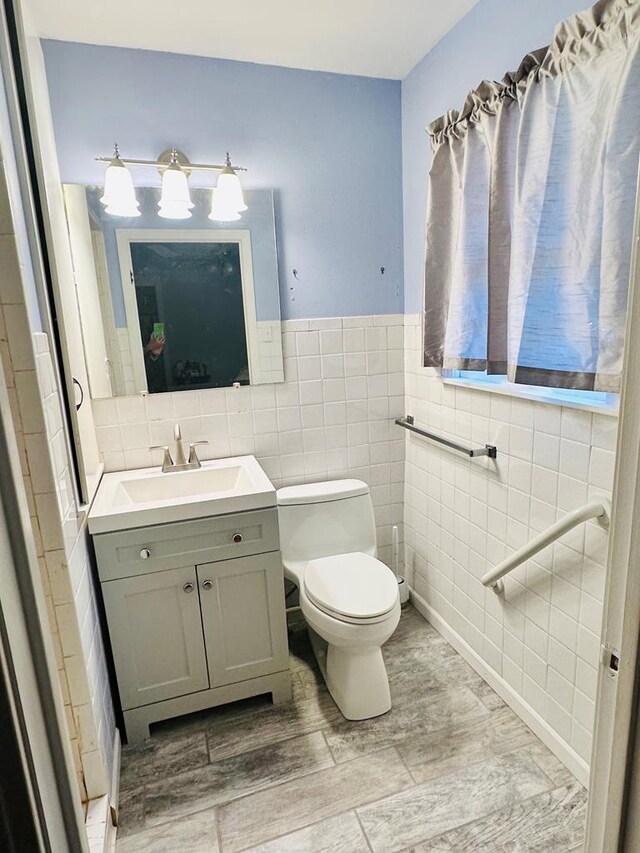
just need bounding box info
[404,316,617,763]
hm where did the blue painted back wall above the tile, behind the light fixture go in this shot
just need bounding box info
[43,41,403,318]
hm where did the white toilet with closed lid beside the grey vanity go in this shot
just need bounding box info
[278,480,400,720]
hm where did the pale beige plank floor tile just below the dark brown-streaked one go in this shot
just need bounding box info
[219,749,412,853]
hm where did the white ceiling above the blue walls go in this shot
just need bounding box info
[28,0,478,79]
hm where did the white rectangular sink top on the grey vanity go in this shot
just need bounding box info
[89,456,276,533]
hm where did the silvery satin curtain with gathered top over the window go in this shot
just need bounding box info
[424,0,640,391]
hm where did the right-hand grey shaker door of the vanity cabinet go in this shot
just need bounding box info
[198,552,289,687]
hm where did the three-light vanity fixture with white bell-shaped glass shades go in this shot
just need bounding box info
[96,145,247,222]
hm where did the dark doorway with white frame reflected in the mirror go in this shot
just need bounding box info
[117,228,252,394]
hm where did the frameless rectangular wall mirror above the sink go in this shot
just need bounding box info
[64,184,284,399]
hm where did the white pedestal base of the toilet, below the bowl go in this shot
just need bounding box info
[308,628,391,720]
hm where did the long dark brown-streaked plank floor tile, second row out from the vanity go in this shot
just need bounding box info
[145,732,333,825]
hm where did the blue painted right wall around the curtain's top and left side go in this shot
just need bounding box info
[402,0,589,314]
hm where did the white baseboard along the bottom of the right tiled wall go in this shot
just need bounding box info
[410,589,589,788]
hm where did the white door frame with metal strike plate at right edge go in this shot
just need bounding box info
[584,170,640,853]
